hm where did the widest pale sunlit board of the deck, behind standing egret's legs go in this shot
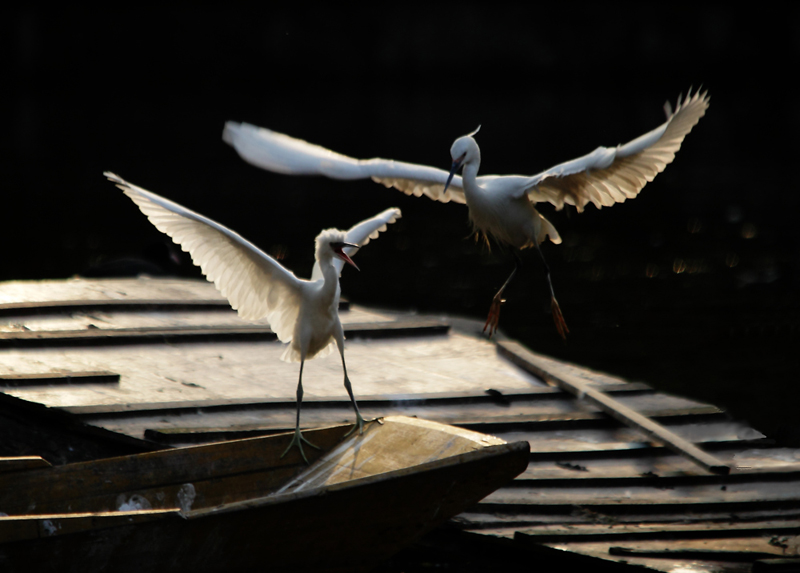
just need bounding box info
[0,334,541,407]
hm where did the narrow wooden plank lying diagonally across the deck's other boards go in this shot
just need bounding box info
[498,341,730,474]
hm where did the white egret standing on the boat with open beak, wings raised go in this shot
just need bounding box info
[104,172,401,462]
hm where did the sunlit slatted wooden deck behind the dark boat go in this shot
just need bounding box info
[0,278,800,571]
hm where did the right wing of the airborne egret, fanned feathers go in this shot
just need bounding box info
[527,90,709,211]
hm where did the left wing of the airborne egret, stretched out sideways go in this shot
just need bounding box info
[222,121,466,203]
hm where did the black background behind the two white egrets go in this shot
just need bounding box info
[6,8,800,445]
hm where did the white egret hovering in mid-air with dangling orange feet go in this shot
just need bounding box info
[222,90,709,338]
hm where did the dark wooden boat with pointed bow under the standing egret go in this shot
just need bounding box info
[0,416,529,573]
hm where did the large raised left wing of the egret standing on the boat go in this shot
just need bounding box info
[104,172,306,342]
